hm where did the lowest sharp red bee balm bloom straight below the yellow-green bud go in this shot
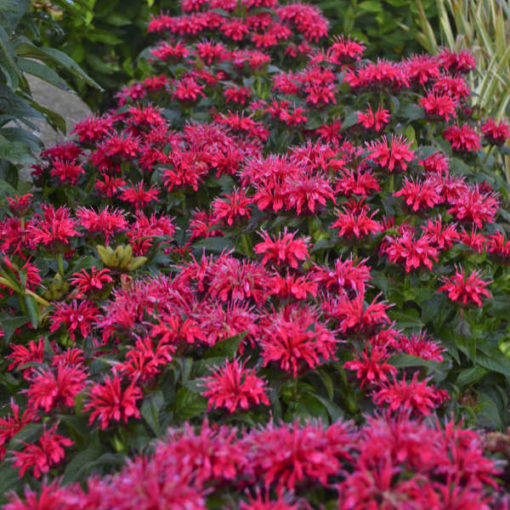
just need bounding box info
[85,375,142,430]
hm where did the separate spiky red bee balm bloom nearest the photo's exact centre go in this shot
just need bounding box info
[254,229,309,269]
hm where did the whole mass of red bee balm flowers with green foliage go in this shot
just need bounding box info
[0,0,510,504]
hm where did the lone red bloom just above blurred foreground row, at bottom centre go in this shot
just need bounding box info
[203,359,269,413]
